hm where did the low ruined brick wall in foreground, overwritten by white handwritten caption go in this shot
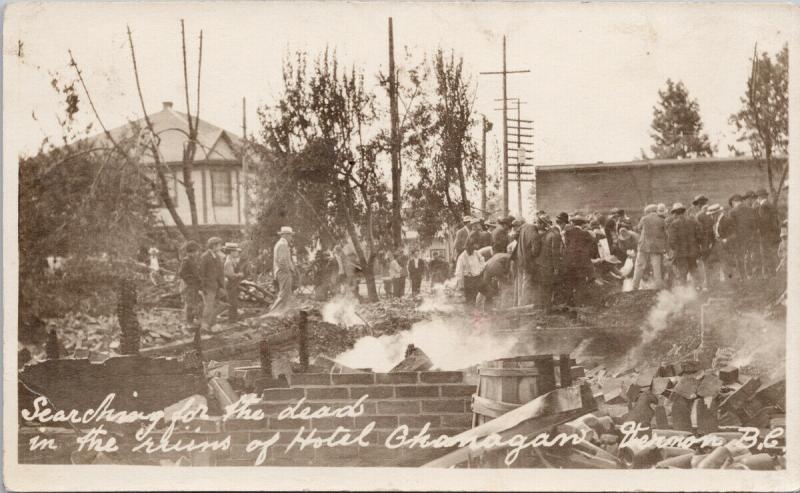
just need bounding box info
[20,371,475,466]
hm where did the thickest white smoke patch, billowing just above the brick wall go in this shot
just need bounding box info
[334,317,517,372]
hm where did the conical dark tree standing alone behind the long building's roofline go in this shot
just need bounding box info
[650,79,714,159]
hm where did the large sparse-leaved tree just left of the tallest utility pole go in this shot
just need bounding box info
[259,50,391,301]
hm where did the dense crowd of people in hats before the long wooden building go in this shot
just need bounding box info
[453,189,787,310]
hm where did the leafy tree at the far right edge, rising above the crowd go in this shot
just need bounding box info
[729,44,789,202]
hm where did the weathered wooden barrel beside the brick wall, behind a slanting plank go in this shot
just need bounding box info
[472,354,556,426]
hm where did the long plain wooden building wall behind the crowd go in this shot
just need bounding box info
[534,157,785,218]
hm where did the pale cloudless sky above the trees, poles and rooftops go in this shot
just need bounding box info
[4,2,798,213]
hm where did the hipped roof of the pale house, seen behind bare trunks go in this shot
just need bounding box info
[89,101,242,164]
